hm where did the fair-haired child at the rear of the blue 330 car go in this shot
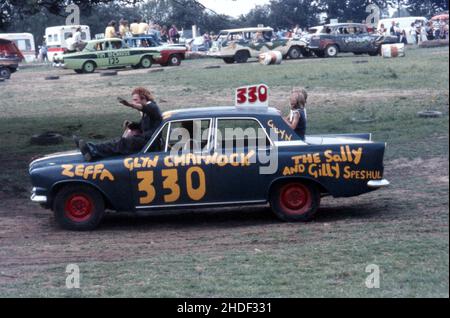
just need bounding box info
[285,88,308,141]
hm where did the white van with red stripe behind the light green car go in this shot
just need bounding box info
[45,25,91,61]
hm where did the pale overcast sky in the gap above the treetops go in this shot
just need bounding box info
[198,0,270,17]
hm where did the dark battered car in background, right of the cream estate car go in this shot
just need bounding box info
[302,23,397,57]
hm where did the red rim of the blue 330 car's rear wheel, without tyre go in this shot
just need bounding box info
[280,183,312,215]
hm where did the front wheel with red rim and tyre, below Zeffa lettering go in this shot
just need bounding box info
[53,185,105,231]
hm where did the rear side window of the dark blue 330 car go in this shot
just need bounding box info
[215,118,270,152]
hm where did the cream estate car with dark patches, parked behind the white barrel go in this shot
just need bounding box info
[208,27,306,63]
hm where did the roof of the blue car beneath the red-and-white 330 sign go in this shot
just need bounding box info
[163,106,280,121]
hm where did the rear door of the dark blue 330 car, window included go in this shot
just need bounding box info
[211,117,272,203]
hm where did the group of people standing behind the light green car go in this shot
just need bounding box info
[105,19,180,43]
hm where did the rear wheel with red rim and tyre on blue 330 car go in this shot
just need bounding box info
[270,181,320,222]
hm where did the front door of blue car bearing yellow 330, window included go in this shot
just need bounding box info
[128,118,213,210]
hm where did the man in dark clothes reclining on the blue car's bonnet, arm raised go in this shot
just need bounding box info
[74,87,162,161]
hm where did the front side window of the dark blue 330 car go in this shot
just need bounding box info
[166,119,212,153]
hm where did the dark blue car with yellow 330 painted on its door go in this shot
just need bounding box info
[29,107,389,230]
